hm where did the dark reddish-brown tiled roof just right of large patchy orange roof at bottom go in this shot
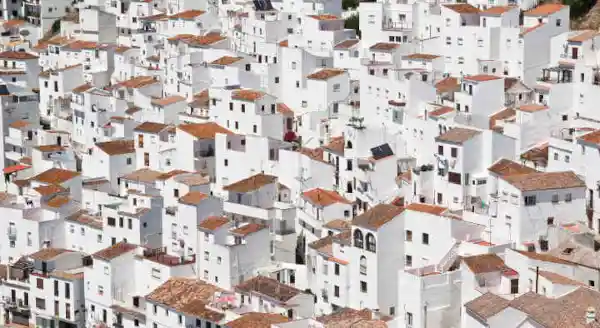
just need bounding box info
[234,276,303,303]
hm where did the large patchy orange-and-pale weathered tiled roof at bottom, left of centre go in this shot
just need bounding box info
[146,277,225,322]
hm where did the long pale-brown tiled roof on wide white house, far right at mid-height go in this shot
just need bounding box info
[502,171,585,192]
